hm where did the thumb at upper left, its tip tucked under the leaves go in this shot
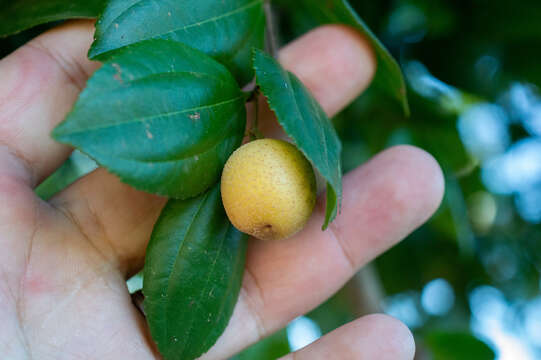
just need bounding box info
[0,21,98,185]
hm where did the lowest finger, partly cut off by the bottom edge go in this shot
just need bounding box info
[281,315,415,360]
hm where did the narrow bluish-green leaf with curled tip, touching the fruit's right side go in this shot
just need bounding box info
[254,50,342,229]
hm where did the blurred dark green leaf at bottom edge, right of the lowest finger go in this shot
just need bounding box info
[424,331,496,360]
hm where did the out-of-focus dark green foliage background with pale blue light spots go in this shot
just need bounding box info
[0,0,541,360]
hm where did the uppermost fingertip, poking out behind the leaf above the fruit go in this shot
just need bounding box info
[280,25,376,116]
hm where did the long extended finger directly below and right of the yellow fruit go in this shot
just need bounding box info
[199,146,444,360]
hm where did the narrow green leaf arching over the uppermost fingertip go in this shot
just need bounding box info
[275,0,409,116]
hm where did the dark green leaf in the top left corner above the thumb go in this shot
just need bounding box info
[0,0,105,37]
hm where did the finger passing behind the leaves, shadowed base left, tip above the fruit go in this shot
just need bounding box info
[53,26,374,273]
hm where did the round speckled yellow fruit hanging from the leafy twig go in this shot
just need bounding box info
[221,139,316,240]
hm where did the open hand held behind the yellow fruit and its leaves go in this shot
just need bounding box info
[0,21,443,360]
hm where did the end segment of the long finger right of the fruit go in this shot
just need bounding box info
[332,145,444,266]
